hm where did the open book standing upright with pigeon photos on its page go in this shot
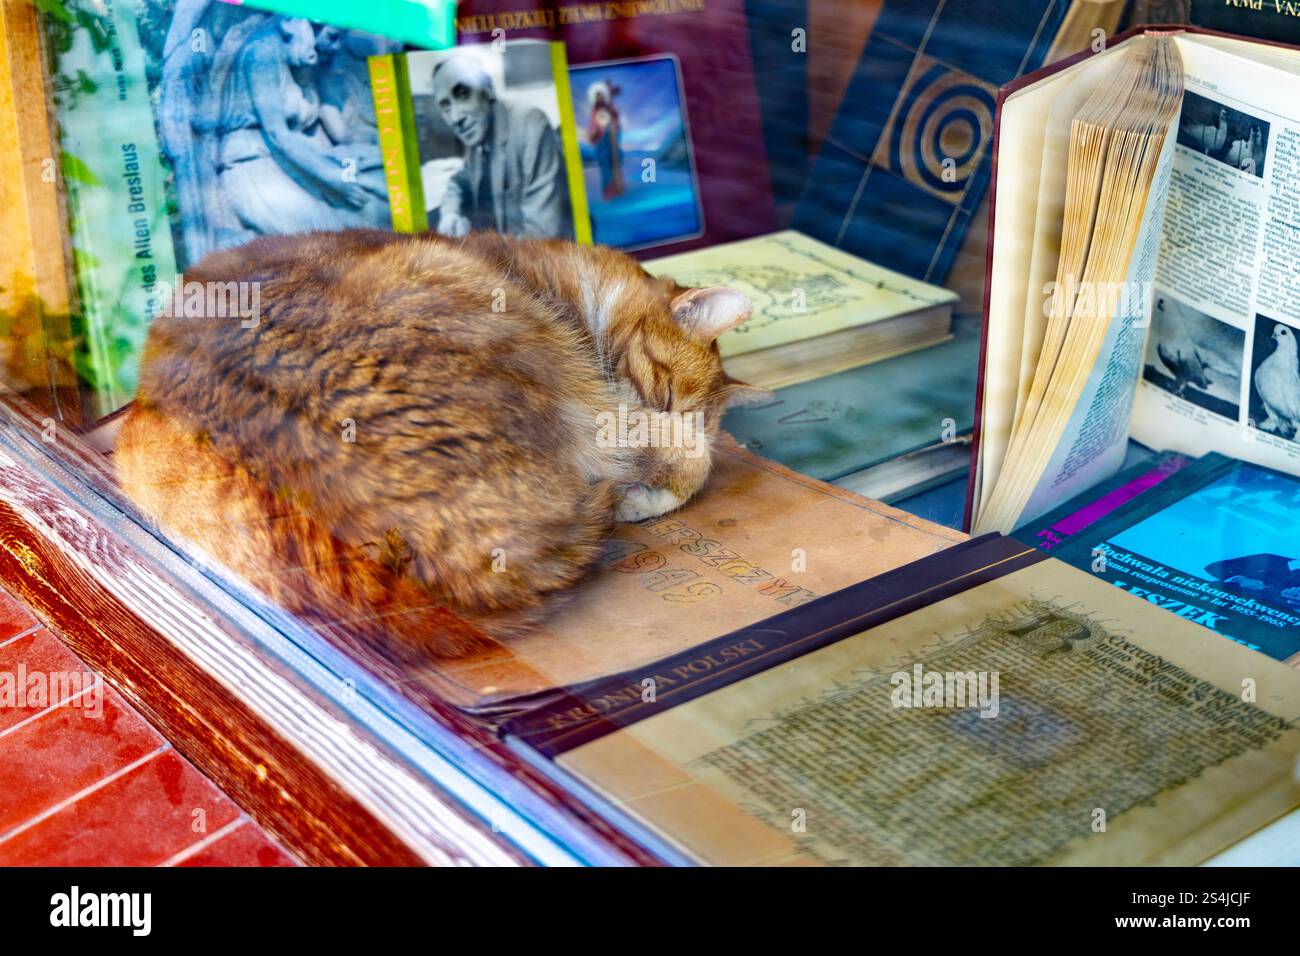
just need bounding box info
[970,29,1300,531]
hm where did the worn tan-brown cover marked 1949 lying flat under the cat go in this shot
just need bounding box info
[418,442,965,711]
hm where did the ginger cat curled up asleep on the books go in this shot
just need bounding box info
[114,232,750,656]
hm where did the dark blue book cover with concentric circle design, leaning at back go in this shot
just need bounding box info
[792,0,1070,284]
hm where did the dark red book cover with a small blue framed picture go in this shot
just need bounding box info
[456,0,776,258]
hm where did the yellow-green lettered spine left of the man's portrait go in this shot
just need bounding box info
[369,53,429,233]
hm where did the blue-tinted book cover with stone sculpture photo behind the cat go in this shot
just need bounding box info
[140,0,400,263]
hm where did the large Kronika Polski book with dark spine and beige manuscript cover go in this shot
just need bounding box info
[506,536,1300,866]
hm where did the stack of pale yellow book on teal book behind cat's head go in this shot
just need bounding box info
[646,230,978,501]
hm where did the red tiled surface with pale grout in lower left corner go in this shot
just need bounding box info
[0,591,298,866]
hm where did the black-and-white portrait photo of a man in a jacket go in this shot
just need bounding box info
[408,42,573,238]
